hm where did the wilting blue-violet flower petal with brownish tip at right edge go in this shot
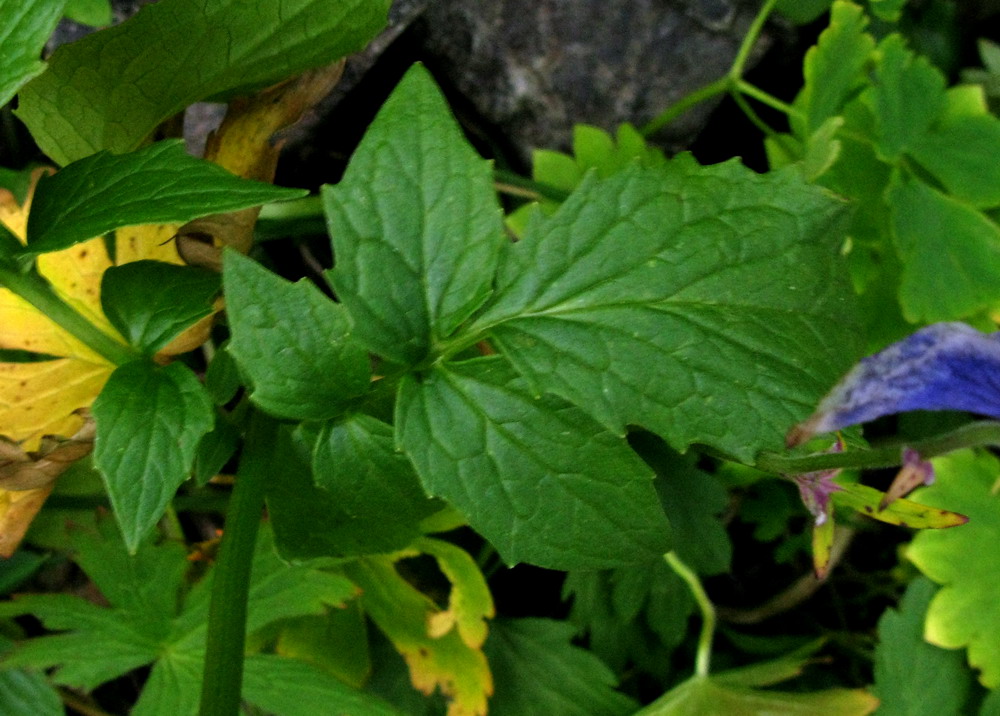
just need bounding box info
[788,323,1000,445]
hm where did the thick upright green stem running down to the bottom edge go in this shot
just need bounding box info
[199,413,276,716]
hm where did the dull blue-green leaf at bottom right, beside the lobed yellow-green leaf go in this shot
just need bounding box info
[874,578,971,716]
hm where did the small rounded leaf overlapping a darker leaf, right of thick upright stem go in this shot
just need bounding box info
[312,414,440,549]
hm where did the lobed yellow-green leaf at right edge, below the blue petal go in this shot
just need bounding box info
[906,450,1000,689]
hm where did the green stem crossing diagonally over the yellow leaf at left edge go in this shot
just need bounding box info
[0,266,139,365]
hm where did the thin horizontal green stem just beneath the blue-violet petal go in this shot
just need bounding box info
[754,420,1000,475]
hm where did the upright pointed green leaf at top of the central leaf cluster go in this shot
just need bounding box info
[323,65,503,365]
